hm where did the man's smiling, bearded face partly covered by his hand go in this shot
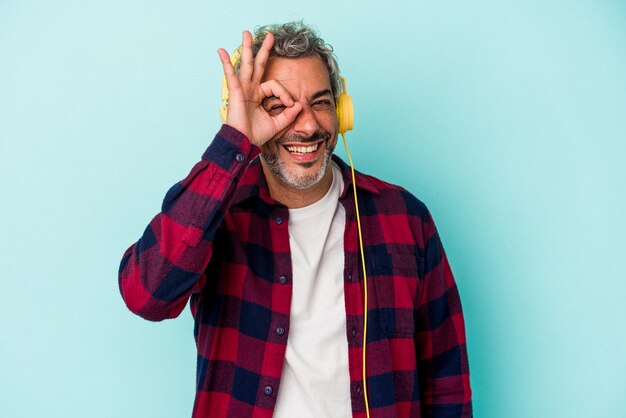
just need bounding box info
[261,56,337,190]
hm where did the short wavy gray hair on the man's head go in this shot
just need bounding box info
[235,21,341,100]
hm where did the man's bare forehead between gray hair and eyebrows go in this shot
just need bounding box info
[263,55,331,94]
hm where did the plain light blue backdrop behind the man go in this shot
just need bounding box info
[0,0,626,418]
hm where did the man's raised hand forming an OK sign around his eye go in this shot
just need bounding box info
[218,31,302,147]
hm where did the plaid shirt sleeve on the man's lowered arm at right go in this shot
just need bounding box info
[415,214,472,418]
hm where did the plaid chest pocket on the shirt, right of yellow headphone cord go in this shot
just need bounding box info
[368,252,421,337]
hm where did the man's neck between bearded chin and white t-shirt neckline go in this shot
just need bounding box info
[261,160,333,209]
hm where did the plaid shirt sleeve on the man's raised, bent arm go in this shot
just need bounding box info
[119,125,258,321]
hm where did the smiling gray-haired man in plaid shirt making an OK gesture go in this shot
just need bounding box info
[119,23,472,418]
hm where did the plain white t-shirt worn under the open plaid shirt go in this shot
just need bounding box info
[274,162,352,418]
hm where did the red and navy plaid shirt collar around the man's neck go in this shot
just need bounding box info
[233,154,380,205]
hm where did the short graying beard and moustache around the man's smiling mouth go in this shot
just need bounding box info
[261,131,336,190]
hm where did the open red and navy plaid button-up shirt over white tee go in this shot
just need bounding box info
[119,125,472,418]
